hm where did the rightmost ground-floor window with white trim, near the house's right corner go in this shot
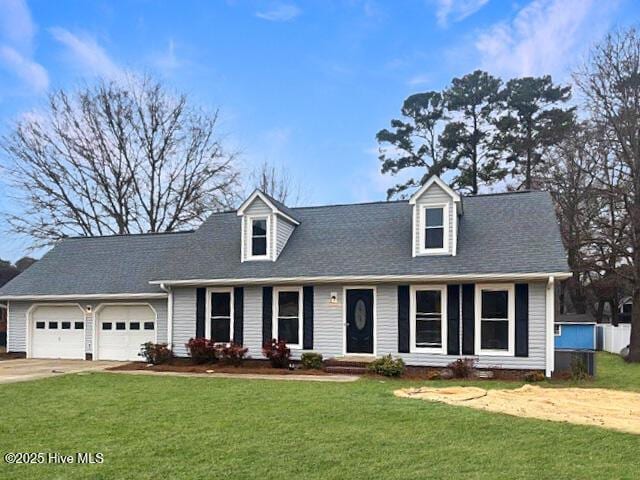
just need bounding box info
[476,285,515,355]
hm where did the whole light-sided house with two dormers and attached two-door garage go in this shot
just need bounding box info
[0,177,570,375]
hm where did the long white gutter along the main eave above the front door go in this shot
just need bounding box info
[149,272,572,286]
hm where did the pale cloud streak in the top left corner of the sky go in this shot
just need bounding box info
[0,0,49,92]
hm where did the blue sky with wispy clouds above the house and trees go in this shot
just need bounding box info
[0,0,640,260]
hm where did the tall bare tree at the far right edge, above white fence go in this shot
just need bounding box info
[575,28,640,362]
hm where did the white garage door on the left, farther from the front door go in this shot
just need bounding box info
[31,305,85,359]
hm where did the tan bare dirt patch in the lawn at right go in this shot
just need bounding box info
[394,385,640,435]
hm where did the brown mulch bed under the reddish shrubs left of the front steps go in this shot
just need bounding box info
[108,358,331,375]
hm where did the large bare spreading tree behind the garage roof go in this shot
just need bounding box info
[1,76,238,246]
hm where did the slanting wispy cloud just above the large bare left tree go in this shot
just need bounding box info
[49,27,125,80]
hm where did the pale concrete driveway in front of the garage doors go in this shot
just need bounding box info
[0,359,121,384]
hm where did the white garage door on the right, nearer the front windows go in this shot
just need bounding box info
[96,305,156,361]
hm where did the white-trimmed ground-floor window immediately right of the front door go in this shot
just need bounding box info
[411,286,447,353]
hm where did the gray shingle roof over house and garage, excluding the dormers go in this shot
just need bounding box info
[0,192,568,296]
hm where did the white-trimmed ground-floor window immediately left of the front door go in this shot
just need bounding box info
[273,288,302,348]
